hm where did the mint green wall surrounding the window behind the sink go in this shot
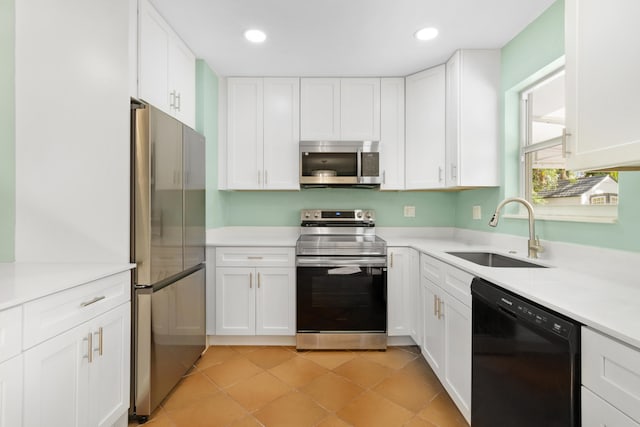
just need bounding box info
[455,0,640,252]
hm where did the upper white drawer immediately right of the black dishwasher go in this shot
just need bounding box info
[582,327,640,421]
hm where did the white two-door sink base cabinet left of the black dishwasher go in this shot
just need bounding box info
[420,254,473,421]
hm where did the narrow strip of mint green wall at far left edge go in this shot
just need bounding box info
[0,0,16,262]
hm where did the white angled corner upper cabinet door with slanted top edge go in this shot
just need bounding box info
[405,65,445,190]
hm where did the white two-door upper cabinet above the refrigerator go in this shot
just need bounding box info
[138,0,196,127]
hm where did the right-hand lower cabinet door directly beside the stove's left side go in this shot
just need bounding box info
[256,268,296,335]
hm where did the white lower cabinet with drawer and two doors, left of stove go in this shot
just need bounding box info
[215,248,296,336]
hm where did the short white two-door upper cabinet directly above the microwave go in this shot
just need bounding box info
[300,78,380,141]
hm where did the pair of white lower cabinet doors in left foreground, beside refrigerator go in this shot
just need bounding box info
[24,303,131,427]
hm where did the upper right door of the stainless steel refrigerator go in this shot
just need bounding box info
[182,126,206,269]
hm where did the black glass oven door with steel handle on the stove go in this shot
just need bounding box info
[296,257,387,333]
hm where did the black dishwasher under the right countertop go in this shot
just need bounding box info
[471,278,580,427]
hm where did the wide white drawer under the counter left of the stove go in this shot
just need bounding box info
[216,247,295,267]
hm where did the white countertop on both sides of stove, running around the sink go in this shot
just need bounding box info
[207,227,640,348]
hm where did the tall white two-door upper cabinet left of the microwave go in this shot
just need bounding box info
[226,77,300,190]
